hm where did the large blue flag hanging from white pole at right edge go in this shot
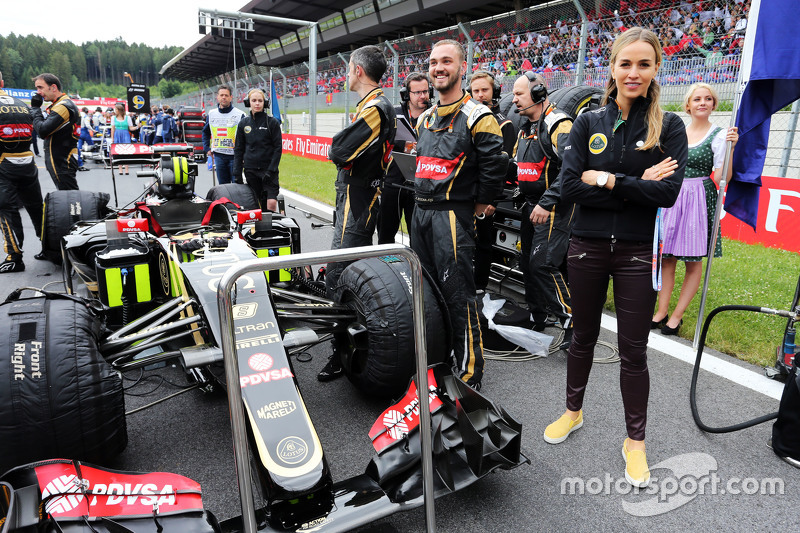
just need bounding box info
[725,0,800,229]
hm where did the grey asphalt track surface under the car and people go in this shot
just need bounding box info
[7,159,800,532]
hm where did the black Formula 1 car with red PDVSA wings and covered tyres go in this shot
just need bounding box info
[0,144,527,533]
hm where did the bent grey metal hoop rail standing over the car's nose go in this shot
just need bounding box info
[217,244,436,533]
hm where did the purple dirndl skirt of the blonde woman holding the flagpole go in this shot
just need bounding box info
[664,178,708,257]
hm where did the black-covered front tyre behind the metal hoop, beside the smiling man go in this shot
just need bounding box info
[334,256,450,398]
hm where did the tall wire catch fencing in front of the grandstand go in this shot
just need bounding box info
[162,0,800,178]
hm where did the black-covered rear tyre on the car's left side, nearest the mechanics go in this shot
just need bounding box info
[42,191,110,265]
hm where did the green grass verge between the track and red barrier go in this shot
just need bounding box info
[280,154,800,366]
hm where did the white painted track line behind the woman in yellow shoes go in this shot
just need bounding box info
[601,314,783,400]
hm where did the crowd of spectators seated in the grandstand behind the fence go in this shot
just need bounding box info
[266,0,750,96]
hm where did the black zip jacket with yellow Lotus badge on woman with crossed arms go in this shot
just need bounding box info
[560,97,689,242]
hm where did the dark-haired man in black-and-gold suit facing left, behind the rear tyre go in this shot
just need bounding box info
[31,73,81,191]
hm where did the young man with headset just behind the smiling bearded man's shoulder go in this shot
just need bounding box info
[469,70,517,294]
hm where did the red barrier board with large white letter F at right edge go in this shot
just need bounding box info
[722,176,800,252]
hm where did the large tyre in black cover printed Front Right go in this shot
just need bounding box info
[0,290,128,471]
